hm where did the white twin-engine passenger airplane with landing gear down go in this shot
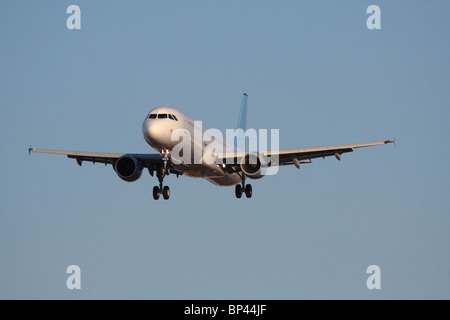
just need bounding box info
[28,93,394,200]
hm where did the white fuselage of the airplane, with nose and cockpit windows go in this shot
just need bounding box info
[142,107,241,186]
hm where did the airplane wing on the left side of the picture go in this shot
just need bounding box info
[28,148,164,170]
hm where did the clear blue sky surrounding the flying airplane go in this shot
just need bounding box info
[0,0,450,299]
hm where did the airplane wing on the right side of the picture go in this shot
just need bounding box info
[218,140,394,168]
